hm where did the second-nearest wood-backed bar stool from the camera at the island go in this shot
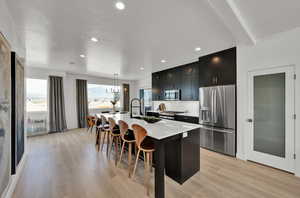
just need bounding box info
[118,120,135,177]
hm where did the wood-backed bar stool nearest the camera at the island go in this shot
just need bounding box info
[132,124,155,195]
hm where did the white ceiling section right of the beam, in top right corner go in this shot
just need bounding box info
[234,0,300,39]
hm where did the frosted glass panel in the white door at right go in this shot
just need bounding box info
[253,73,285,157]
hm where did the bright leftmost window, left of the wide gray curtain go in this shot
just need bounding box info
[26,78,48,135]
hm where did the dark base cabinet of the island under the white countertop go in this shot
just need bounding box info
[165,129,200,184]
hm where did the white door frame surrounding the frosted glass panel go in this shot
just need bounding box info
[245,66,295,173]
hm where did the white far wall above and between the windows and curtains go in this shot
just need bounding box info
[26,68,138,129]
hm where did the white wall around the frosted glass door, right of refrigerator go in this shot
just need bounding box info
[237,28,300,176]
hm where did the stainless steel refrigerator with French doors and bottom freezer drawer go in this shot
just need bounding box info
[199,85,236,156]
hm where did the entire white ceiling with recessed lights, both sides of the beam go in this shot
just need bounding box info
[7,0,300,79]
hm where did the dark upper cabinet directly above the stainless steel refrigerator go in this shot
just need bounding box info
[199,48,236,87]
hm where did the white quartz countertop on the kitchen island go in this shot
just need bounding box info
[102,114,200,140]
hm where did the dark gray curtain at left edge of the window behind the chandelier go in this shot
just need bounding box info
[76,79,89,128]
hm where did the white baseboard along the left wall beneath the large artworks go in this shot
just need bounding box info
[2,152,27,198]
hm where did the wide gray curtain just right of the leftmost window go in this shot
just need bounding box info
[49,76,67,133]
